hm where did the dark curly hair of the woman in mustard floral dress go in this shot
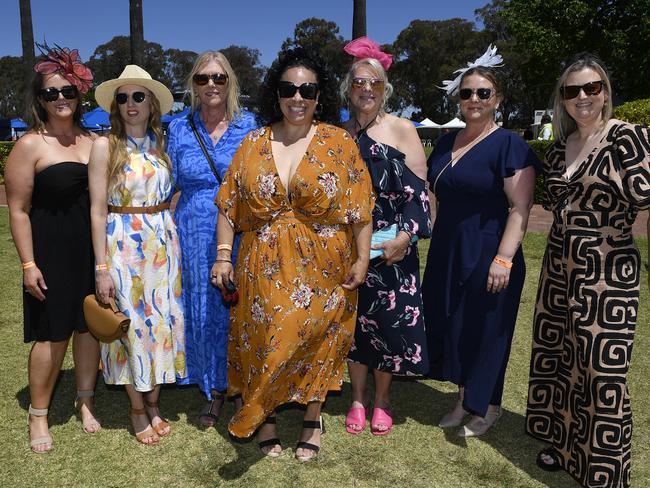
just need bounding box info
[259,48,341,125]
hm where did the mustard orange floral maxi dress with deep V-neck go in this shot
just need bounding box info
[216,124,374,437]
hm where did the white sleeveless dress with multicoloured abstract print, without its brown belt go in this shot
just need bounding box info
[101,136,186,392]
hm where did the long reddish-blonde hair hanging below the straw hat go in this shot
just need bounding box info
[108,87,172,190]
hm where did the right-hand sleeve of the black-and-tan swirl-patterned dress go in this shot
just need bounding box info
[611,123,650,210]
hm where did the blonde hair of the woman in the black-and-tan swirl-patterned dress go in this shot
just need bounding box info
[553,54,612,140]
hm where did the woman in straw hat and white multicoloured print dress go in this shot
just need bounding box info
[89,65,186,445]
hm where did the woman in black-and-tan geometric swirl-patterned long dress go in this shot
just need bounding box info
[526,54,650,488]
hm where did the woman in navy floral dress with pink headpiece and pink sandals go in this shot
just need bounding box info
[341,38,431,435]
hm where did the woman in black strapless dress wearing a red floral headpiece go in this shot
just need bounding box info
[5,48,101,453]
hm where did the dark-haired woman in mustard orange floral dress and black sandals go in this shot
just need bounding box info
[212,50,374,461]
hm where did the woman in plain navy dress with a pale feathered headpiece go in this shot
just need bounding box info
[422,63,539,437]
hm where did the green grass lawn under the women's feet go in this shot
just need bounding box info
[0,208,650,488]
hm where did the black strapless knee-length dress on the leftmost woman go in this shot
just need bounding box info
[23,161,95,342]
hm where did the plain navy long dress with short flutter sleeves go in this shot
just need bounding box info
[422,129,540,417]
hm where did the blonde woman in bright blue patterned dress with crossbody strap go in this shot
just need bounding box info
[168,51,256,427]
